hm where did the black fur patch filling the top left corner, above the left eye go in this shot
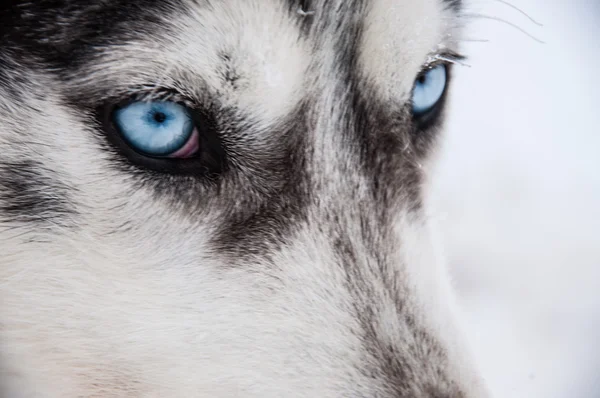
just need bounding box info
[0,0,184,70]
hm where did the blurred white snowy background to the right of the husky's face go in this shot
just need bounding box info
[432,0,600,398]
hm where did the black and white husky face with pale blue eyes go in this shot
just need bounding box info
[0,0,486,398]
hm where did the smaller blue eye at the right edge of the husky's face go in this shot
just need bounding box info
[412,65,447,116]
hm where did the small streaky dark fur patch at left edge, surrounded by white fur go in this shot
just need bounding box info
[0,160,75,225]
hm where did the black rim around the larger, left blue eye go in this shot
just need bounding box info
[96,99,227,178]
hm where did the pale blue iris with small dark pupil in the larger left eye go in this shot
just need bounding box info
[114,101,194,156]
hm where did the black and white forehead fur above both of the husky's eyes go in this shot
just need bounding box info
[3,0,459,122]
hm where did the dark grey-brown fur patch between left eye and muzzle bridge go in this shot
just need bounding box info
[209,104,311,258]
